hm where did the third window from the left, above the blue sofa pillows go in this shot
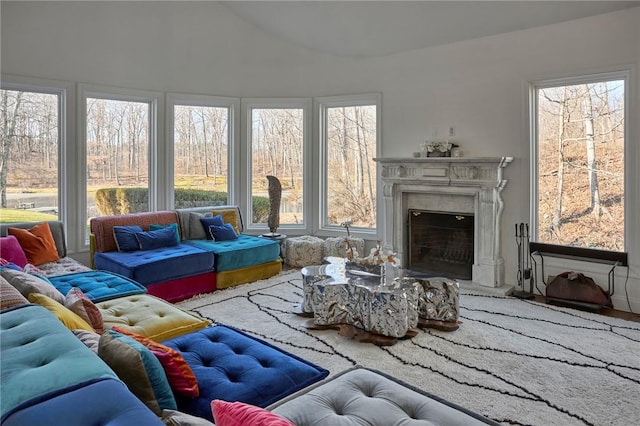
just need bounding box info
[169,96,238,208]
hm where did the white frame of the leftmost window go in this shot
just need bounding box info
[1,74,78,253]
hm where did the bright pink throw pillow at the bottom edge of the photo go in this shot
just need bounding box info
[211,399,296,426]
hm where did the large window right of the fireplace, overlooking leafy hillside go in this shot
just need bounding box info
[532,73,628,251]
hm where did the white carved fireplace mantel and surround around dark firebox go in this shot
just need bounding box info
[375,157,513,287]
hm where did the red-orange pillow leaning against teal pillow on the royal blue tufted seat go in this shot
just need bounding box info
[112,326,200,398]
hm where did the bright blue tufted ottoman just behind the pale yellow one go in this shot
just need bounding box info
[49,271,147,303]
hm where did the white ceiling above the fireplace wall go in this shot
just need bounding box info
[221,0,640,56]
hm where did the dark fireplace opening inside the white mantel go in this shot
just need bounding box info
[407,209,474,280]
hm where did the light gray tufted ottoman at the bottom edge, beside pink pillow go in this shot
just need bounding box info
[267,367,498,426]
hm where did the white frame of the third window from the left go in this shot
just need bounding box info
[164,93,240,209]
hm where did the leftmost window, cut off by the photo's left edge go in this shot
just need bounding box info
[0,84,64,222]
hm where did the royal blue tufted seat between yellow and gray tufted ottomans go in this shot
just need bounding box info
[163,325,329,421]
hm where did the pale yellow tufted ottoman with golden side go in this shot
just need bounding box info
[96,294,210,342]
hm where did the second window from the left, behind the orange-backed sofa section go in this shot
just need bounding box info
[81,89,160,240]
